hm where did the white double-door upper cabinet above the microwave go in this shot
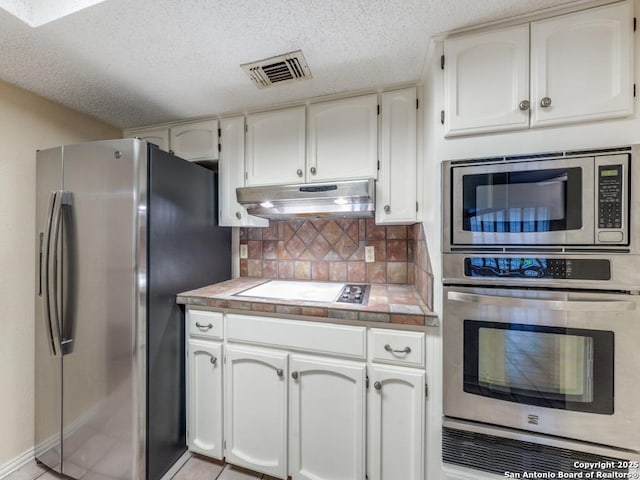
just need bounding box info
[444,0,633,137]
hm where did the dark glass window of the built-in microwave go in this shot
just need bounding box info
[462,167,582,233]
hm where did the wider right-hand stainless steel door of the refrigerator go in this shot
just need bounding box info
[61,139,146,480]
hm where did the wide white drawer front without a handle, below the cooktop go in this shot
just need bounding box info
[226,313,366,359]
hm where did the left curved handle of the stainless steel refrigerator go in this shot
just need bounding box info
[45,190,71,357]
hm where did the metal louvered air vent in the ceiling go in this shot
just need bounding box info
[240,50,311,88]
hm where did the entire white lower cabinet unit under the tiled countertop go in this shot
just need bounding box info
[187,309,425,480]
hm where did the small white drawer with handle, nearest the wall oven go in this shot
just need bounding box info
[369,328,425,367]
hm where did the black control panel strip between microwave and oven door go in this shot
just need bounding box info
[464,257,611,280]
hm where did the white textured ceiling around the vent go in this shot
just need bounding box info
[0,0,568,128]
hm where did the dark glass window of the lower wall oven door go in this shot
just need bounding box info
[464,320,614,414]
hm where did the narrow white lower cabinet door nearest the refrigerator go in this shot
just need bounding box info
[187,340,223,459]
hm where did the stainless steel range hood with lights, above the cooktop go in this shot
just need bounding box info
[236,178,375,220]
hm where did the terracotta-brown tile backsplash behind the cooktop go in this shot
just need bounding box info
[240,219,432,305]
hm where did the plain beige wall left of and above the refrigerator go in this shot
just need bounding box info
[0,81,122,471]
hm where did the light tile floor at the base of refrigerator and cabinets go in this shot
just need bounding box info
[3,455,276,480]
